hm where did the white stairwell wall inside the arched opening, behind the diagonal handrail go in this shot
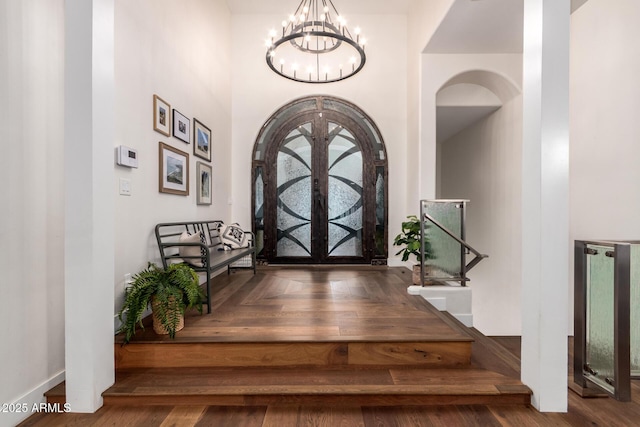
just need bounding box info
[438,96,522,335]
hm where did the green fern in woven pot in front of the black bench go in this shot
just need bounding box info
[118,263,204,343]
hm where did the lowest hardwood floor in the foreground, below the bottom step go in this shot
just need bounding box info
[20,394,640,427]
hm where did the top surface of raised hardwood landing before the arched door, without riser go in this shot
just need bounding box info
[118,266,471,348]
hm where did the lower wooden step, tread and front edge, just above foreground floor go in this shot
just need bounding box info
[97,368,531,406]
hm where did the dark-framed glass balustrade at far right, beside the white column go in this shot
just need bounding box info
[574,241,640,401]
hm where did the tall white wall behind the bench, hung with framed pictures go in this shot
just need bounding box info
[113,0,232,311]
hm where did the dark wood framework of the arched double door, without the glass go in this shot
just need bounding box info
[252,97,387,264]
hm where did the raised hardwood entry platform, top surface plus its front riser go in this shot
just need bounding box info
[115,267,473,369]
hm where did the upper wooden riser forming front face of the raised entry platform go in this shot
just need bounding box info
[115,339,471,370]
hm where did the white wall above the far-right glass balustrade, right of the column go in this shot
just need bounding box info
[570,0,640,242]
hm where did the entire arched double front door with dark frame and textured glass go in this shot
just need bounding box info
[253,96,387,264]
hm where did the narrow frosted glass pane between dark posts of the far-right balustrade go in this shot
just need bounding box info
[585,244,615,393]
